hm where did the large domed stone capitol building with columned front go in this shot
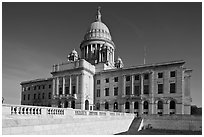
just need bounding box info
[21,8,192,115]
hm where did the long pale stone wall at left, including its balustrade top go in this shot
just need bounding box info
[2,105,134,135]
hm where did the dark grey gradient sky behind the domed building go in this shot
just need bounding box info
[2,2,202,106]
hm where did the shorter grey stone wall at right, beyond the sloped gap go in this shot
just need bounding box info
[143,115,202,131]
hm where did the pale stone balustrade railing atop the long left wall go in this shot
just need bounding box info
[2,104,134,117]
